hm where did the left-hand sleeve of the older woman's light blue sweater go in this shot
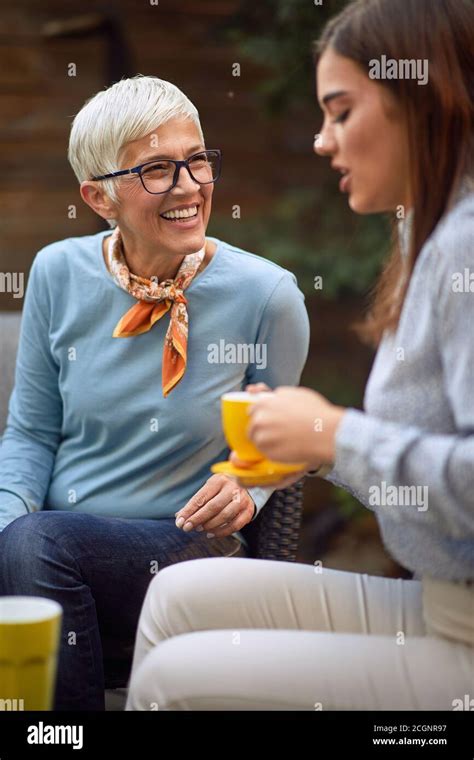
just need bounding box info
[0,252,62,529]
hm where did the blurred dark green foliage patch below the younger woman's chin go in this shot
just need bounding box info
[210,188,390,299]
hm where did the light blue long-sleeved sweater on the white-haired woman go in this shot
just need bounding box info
[0,235,309,529]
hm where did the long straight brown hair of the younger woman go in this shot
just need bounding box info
[315,0,474,345]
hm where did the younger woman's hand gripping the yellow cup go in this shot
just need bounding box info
[248,386,346,470]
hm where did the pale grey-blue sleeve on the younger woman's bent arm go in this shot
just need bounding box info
[320,235,474,538]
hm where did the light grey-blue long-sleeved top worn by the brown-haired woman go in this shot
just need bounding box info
[326,180,474,580]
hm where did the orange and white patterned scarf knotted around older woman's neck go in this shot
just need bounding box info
[107,227,205,397]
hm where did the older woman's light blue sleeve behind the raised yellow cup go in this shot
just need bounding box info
[247,272,309,519]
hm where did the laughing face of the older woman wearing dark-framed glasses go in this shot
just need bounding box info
[110,119,214,256]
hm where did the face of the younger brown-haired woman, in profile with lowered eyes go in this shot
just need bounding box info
[314,48,410,214]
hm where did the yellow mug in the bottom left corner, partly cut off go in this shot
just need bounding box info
[0,596,62,711]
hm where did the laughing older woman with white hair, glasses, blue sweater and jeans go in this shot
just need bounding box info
[0,77,308,710]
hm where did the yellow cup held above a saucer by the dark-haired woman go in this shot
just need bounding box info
[221,391,272,463]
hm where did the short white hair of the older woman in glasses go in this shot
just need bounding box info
[68,74,204,227]
